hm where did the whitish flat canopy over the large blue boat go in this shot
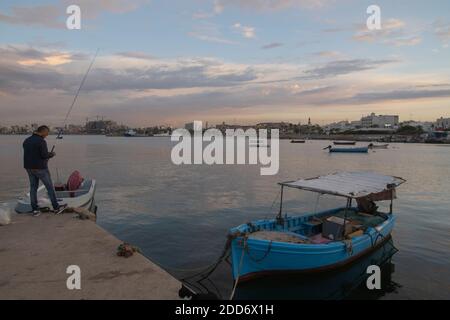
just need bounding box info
[280,172,406,201]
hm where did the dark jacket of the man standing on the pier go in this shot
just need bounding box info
[23,134,53,169]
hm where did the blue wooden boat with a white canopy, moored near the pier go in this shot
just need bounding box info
[229,172,405,283]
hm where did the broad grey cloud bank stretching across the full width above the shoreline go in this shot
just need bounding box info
[0,45,450,125]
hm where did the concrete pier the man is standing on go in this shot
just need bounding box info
[0,213,181,299]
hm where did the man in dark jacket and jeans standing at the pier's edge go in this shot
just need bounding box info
[23,126,65,216]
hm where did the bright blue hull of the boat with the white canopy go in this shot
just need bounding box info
[230,210,396,281]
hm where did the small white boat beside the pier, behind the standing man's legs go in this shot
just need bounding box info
[15,174,97,213]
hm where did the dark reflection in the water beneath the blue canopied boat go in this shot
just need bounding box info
[235,239,398,300]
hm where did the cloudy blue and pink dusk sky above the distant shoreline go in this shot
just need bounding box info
[0,0,450,126]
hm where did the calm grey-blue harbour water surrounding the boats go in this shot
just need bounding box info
[0,136,450,299]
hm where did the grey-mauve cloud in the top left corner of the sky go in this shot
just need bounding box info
[0,0,149,29]
